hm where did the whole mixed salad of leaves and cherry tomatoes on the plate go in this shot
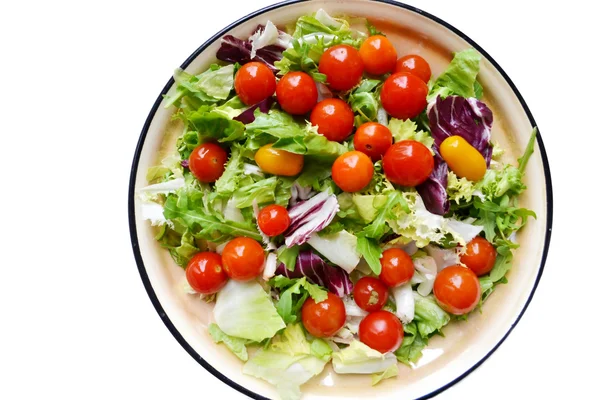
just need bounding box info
[140,10,536,399]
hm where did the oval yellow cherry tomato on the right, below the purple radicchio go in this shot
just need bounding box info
[440,136,487,182]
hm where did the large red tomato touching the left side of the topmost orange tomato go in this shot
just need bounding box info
[319,44,364,90]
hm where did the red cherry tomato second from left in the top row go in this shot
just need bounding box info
[276,72,318,115]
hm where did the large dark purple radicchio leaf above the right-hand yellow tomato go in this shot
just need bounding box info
[427,96,494,167]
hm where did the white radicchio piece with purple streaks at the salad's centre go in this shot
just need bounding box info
[284,192,340,247]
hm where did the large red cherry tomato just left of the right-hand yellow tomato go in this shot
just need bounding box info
[383,140,433,187]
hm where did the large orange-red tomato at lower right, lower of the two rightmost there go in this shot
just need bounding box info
[433,265,481,315]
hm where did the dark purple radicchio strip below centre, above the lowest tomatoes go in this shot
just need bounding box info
[275,250,352,297]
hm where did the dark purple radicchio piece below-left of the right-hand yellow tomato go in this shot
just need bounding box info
[417,154,450,215]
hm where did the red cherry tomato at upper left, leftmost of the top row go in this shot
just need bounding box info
[234,62,277,106]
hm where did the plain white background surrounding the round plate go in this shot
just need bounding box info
[0,0,600,399]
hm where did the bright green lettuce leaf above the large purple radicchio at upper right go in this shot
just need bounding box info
[427,49,483,102]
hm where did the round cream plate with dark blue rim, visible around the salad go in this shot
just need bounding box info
[129,0,552,399]
